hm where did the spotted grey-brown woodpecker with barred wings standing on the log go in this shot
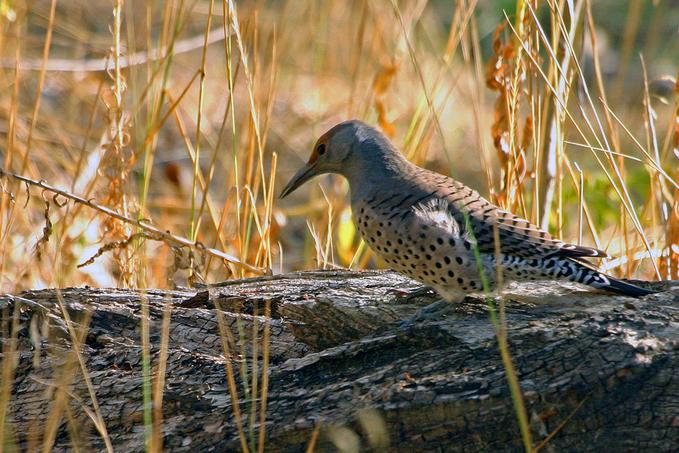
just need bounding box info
[280,120,653,301]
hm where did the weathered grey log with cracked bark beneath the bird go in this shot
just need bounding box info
[0,271,679,452]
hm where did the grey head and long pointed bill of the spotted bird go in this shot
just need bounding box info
[281,120,376,198]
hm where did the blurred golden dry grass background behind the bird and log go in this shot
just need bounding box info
[0,0,679,291]
